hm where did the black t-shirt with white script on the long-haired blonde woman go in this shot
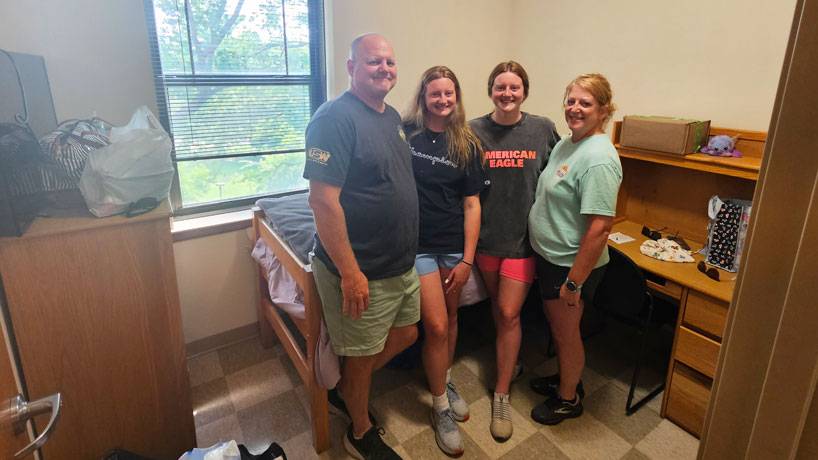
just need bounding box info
[404,124,487,254]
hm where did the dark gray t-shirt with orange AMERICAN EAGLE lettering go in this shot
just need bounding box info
[469,112,560,259]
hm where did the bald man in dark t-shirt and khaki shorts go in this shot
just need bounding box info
[304,34,420,459]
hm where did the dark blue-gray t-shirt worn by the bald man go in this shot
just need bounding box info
[304,92,418,280]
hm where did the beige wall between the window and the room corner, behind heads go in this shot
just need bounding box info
[326,0,510,118]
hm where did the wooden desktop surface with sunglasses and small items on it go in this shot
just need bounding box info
[608,220,736,303]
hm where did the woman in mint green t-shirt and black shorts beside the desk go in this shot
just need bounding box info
[528,74,622,425]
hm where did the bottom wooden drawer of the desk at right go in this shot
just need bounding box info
[665,362,713,438]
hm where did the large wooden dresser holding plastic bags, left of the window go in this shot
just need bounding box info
[0,199,196,460]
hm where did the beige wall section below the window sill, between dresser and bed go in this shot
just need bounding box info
[173,229,258,343]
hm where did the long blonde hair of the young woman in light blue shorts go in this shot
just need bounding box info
[403,65,483,169]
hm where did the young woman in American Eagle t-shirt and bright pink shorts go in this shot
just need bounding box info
[469,61,559,441]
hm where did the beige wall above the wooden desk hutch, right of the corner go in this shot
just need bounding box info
[507,0,795,132]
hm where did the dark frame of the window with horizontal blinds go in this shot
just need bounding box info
[143,0,327,216]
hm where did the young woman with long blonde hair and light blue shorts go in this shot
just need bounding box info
[403,66,486,455]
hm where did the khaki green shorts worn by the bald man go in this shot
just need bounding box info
[312,257,420,356]
